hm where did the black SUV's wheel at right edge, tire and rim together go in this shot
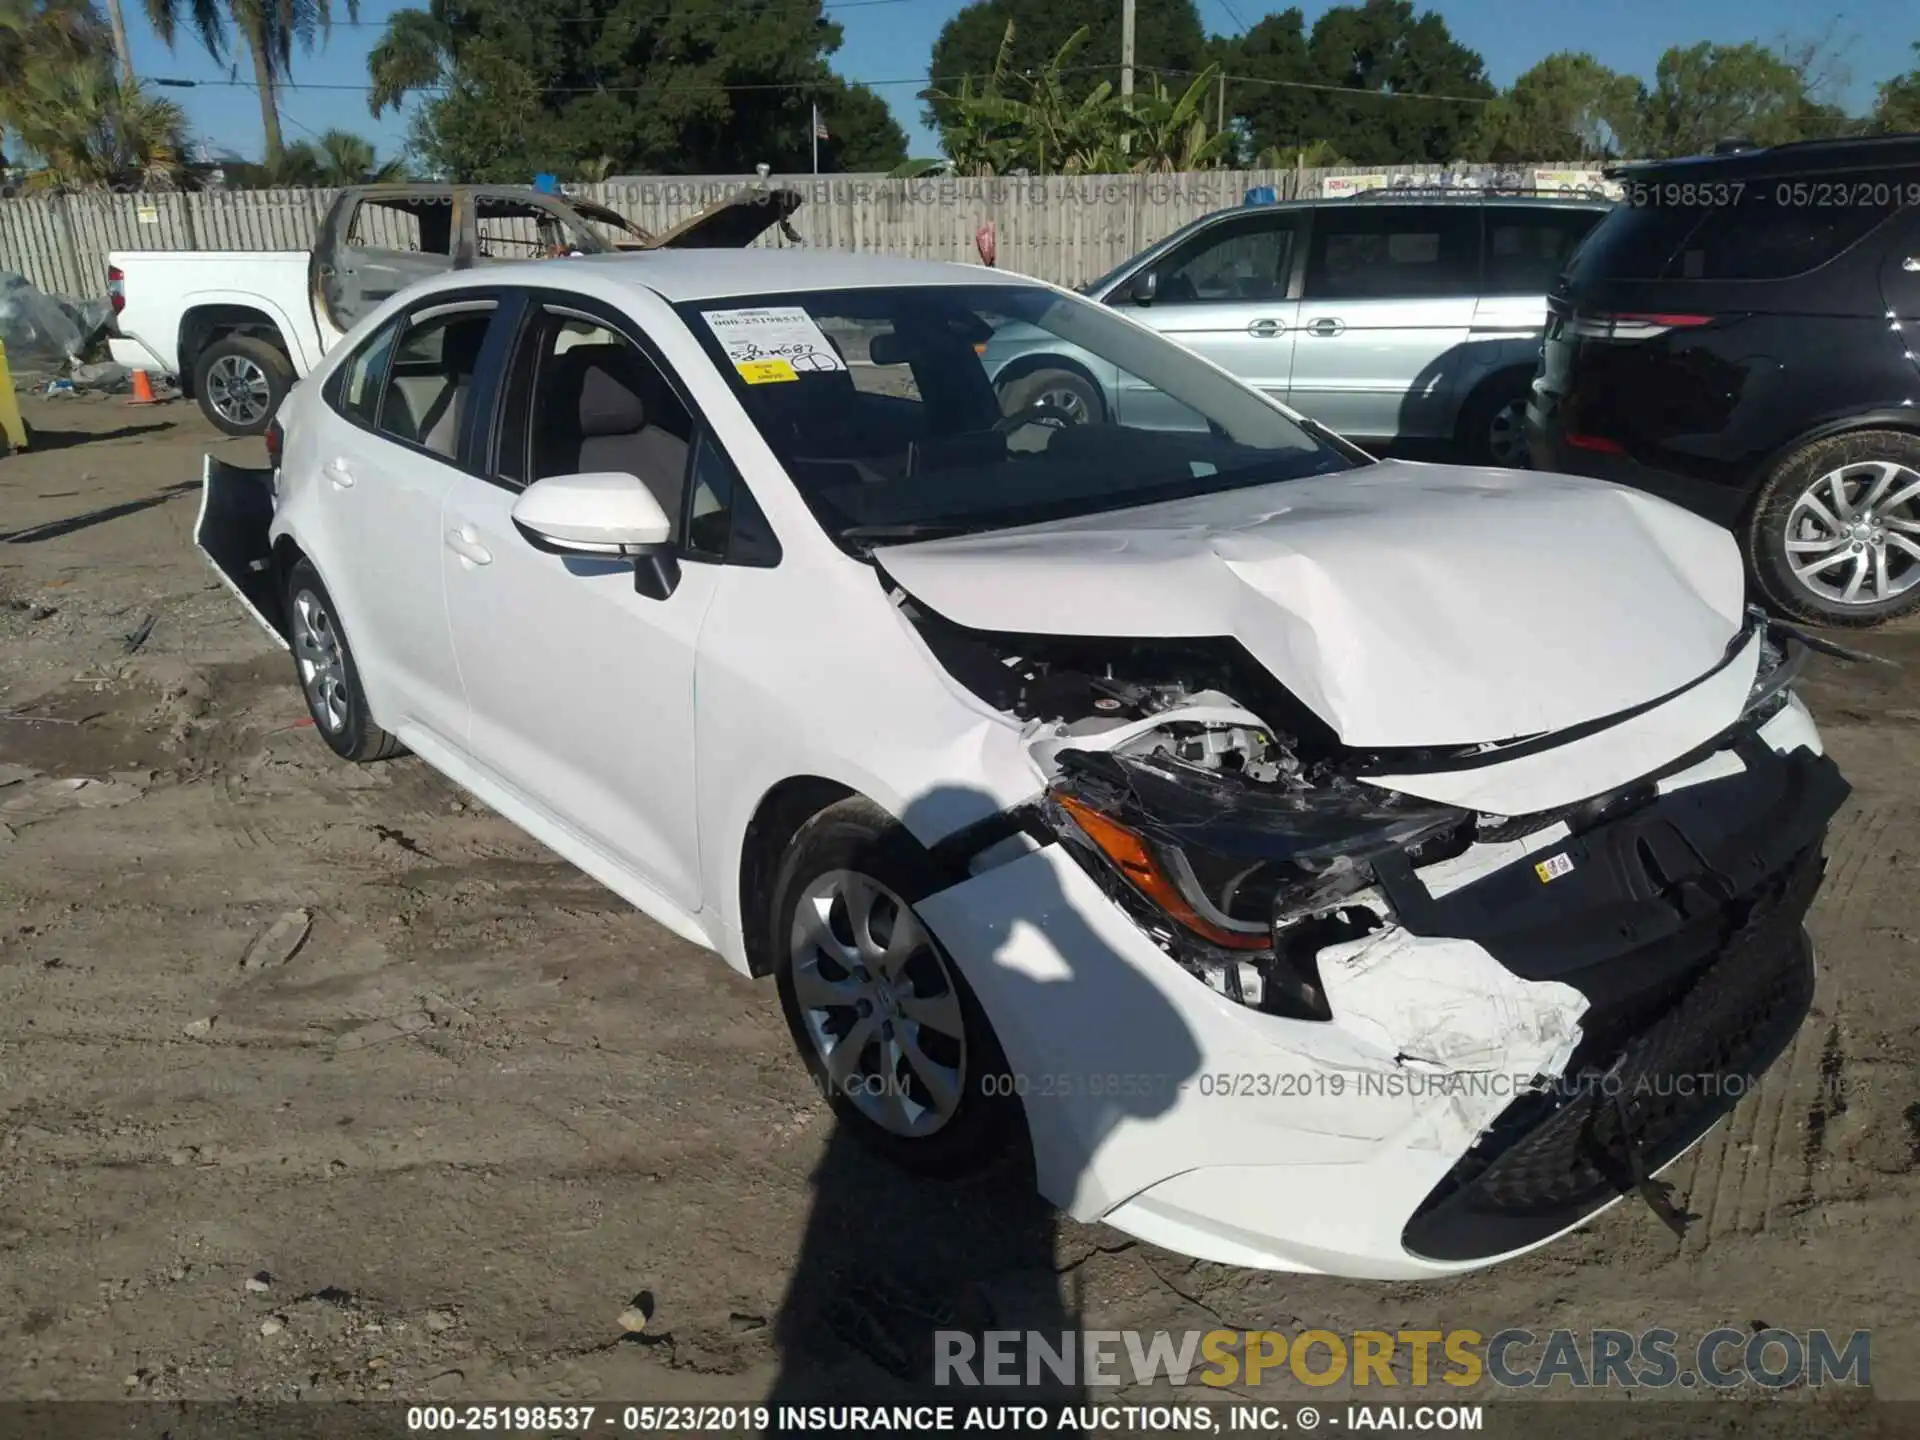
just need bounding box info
[1745,430,1920,626]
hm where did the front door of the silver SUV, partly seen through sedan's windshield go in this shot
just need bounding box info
[1112,209,1300,428]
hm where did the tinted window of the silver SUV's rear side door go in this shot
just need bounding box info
[1306,205,1480,300]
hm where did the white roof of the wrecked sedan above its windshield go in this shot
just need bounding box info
[495,248,1039,301]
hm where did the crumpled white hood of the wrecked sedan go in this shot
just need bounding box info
[874,461,1745,747]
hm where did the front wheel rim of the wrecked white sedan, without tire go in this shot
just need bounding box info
[791,870,968,1139]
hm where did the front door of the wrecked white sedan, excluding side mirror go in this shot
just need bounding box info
[442,290,724,910]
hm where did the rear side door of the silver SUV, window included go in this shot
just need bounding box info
[1288,200,1480,440]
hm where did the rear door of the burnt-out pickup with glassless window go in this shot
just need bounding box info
[313,190,455,339]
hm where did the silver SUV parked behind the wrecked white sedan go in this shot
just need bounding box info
[985,190,1609,467]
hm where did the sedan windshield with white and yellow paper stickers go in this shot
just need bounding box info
[680,284,1356,553]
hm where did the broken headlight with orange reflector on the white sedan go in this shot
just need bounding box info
[1052,751,1473,1008]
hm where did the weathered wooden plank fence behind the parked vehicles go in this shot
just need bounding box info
[0,165,1601,298]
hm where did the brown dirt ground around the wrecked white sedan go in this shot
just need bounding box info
[0,399,1920,1400]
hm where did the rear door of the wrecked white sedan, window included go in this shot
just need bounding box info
[301,294,499,743]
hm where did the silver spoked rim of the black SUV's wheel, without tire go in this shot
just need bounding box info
[1786,461,1920,605]
